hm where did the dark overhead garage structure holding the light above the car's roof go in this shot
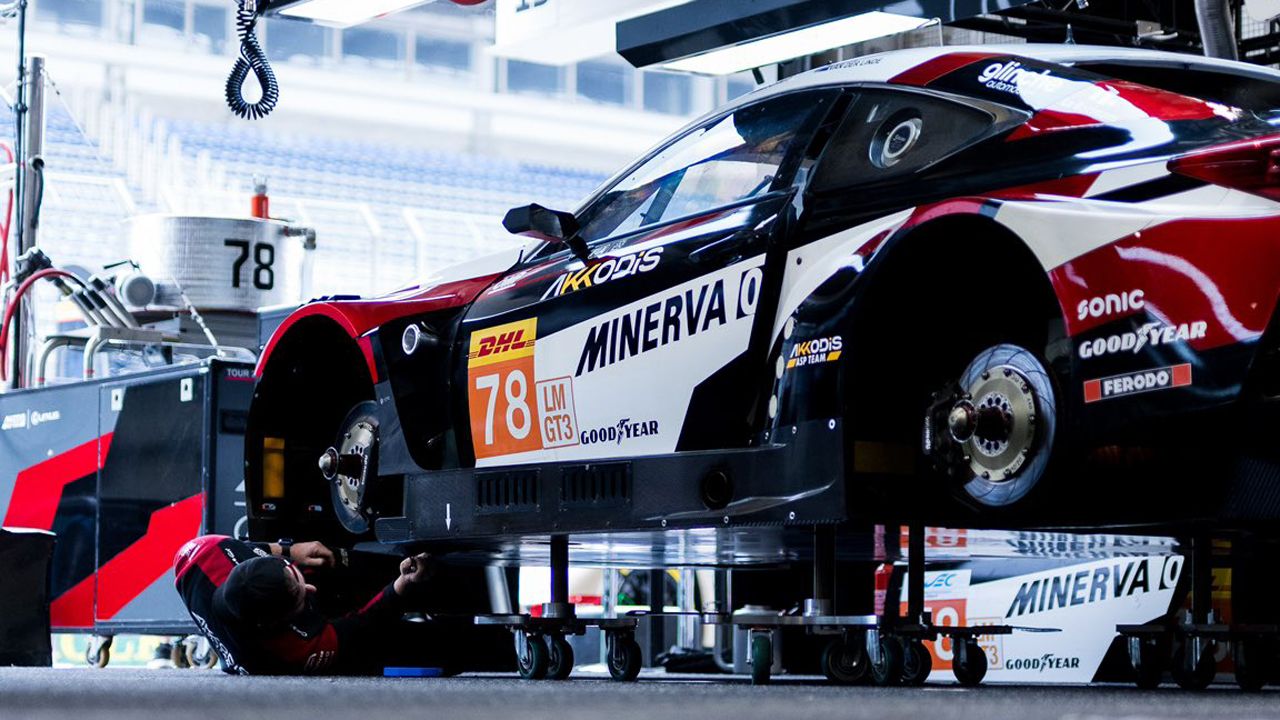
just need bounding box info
[617,0,1280,74]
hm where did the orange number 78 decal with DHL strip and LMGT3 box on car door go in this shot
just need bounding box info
[467,318,579,460]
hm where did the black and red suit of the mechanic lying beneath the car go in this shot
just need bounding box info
[174,536,403,675]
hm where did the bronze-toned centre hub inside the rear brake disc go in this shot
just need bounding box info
[947,366,1036,483]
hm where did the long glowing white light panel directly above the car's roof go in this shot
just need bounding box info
[662,12,934,76]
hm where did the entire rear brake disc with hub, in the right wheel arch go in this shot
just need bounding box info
[925,343,1060,509]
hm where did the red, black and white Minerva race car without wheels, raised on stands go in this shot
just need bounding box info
[246,45,1280,555]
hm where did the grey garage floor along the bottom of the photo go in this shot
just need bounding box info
[0,669,1280,720]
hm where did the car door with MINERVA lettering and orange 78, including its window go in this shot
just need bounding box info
[457,90,838,466]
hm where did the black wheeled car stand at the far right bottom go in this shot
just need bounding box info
[1116,536,1280,692]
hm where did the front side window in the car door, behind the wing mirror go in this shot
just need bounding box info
[581,92,833,242]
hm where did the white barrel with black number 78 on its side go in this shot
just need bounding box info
[128,214,307,311]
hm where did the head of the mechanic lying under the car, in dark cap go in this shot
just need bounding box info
[215,556,315,628]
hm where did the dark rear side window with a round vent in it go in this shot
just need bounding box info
[810,90,996,192]
